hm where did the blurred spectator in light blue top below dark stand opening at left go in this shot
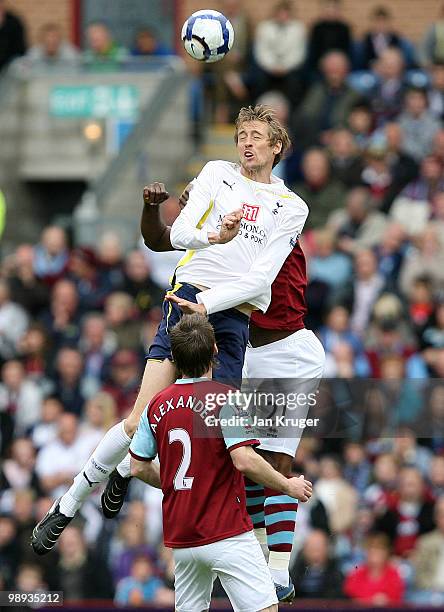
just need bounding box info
[34,225,69,285]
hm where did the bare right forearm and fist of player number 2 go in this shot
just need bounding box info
[230,446,312,502]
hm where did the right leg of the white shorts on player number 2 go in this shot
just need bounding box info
[212,531,278,612]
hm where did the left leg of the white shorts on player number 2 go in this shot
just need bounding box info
[173,546,216,612]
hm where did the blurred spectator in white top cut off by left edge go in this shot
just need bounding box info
[0,279,29,359]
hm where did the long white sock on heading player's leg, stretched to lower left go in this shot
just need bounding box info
[60,421,131,516]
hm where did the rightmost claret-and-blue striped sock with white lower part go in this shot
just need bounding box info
[264,488,298,586]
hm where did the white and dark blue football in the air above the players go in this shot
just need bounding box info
[182,10,234,63]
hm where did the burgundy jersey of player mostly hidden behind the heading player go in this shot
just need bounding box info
[251,242,307,332]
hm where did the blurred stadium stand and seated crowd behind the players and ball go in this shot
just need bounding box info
[0,0,444,610]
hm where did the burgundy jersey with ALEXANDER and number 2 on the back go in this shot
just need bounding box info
[130,379,259,548]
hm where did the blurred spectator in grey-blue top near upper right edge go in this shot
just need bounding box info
[399,89,440,161]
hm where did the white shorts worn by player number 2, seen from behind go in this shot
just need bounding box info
[173,531,278,612]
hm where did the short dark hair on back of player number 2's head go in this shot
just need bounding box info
[170,313,216,378]
